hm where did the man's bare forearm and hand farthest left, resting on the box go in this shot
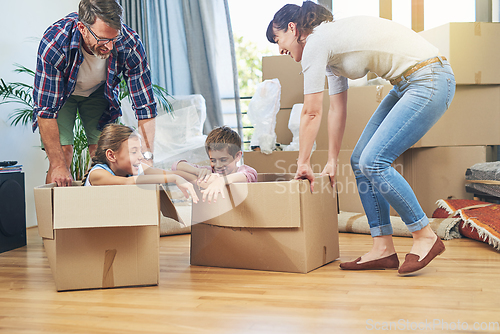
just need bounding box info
[38,117,73,187]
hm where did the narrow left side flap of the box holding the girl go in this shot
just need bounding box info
[34,183,55,239]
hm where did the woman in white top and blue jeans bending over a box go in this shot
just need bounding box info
[267,1,455,274]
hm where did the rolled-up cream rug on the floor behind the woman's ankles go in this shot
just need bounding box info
[338,211,461,240]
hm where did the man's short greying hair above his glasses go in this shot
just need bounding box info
[78,0,123,30]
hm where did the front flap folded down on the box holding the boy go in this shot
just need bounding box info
[192,176,300,228]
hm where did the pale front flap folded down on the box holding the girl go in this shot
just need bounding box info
[53,184,159,229]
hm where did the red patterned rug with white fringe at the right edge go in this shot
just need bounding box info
[433,199,500,251]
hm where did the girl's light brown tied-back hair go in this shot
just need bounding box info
[82,124,140,185]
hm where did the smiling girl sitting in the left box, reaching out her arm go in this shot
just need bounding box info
[82,124,198,203]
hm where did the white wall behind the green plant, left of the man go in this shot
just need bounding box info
[0,0,79,226]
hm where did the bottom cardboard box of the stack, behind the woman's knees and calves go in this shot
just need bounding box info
[337,146,496,217]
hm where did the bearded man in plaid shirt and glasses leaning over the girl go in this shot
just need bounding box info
[33,0,157,186]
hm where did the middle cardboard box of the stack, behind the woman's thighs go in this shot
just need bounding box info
[336,85,500,150]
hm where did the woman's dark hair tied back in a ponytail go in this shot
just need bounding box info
[266,1,333,43]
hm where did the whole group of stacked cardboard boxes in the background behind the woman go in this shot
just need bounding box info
[245,22,500,217]
